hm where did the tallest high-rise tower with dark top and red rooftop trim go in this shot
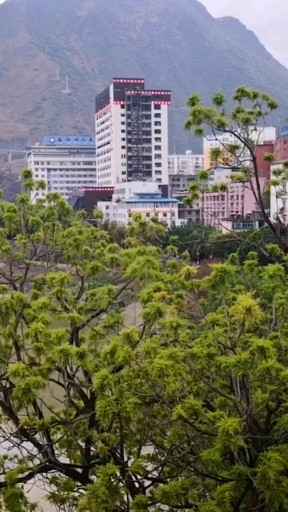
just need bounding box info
[95,78,171,187]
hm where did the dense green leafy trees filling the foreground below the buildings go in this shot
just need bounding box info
[0,173,288,512]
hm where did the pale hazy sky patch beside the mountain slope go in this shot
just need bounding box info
[200,0,288,67]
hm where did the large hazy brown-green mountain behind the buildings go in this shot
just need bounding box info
[0,0,288,151]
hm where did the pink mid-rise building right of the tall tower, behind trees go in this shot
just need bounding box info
[202,178,266,230]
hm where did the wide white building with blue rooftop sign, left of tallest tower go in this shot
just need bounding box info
[27,136,96,201]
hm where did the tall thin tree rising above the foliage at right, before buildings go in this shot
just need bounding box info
[185,86,287,251]
